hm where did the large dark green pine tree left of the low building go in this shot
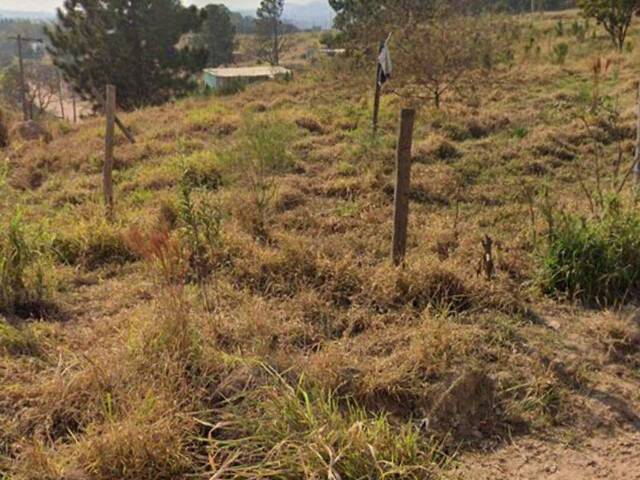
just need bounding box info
[46,0,206,109]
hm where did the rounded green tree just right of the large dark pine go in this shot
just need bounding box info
[200,5,236,67]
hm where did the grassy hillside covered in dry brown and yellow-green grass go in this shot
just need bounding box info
[0,12,640,480]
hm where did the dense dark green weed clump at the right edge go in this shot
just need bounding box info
[541,208,640,305]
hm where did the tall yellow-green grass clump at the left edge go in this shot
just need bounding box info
[0,213,51,316]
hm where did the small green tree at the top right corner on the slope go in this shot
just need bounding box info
[578,0,640,50]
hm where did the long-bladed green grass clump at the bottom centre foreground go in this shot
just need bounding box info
[212,367,445,479]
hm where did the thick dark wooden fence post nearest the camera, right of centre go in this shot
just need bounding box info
[392,109,416,266]
